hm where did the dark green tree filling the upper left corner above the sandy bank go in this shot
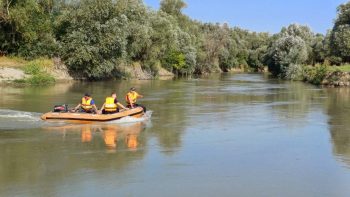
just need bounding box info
[0,0,57,58]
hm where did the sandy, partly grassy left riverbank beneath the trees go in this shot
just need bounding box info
[0,56,175,84]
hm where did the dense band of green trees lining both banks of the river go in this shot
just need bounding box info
[0,0,350,80]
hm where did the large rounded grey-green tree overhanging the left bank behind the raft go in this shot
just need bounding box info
[61,0,129,79]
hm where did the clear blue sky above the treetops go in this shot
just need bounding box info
[144,0,348,34]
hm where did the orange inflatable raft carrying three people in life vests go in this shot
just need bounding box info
[41,107,144,122]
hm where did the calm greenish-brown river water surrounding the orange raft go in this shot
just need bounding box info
[0,74,350,197]
